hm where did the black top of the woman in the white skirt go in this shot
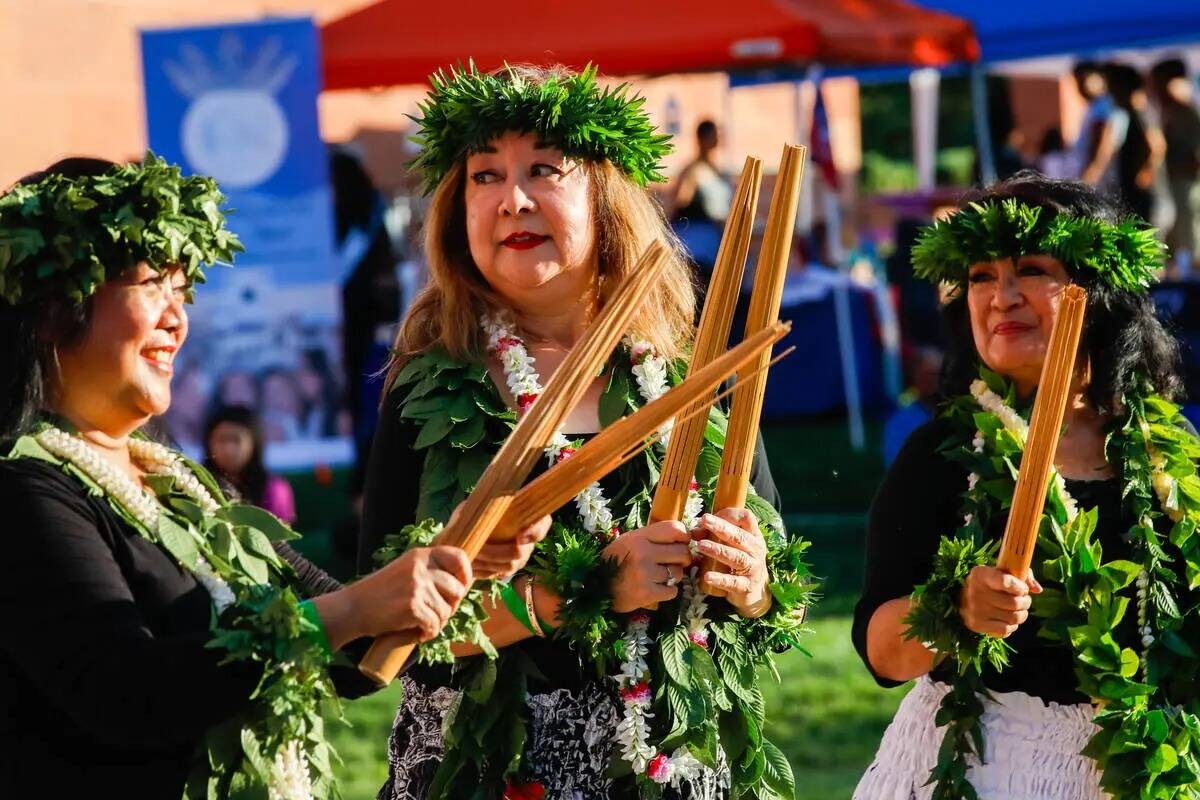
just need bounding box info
[852,419,1133,703]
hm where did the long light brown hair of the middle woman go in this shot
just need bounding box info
[385,67,696,391]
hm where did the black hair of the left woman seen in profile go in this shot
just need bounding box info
[0,157,113,443]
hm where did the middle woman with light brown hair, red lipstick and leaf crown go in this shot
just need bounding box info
[360,65,808,800]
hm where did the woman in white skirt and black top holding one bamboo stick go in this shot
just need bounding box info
[853,173,1200,800]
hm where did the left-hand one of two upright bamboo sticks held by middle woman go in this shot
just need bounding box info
[650,156,762,522]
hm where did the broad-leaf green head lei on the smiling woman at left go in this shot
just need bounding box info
[0,152,242,306]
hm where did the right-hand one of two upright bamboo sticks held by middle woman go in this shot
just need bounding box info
[702,145,806,515]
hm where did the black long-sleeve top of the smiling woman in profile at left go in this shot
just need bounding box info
[0,458,373,800]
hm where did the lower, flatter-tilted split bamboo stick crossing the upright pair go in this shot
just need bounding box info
[491,323,791,542]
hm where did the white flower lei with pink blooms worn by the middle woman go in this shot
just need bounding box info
[482,314,708,787]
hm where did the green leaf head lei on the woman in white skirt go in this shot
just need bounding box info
[912,198,1166,294]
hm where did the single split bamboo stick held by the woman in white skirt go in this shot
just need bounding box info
[996,284,1087,581]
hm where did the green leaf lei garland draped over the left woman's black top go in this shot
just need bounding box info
[7,421,341,800]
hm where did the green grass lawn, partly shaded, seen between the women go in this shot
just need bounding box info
[306,422,904,800]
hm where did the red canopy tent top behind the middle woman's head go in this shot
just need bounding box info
[322,0,978,89]
